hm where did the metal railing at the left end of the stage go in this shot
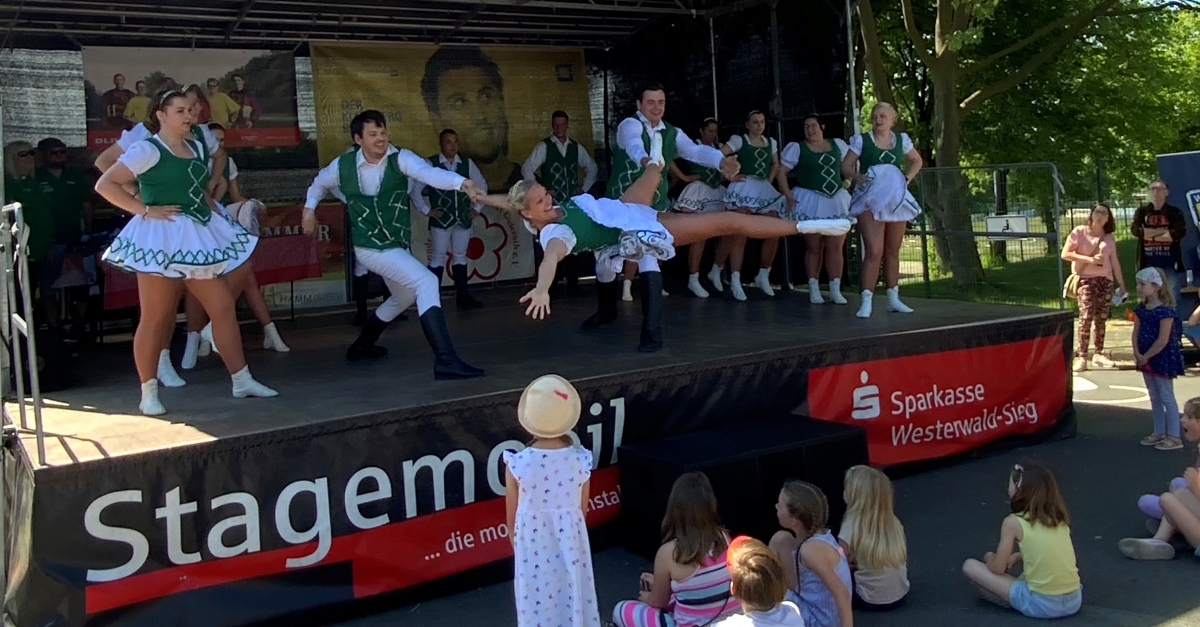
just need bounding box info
[0,203,46,466]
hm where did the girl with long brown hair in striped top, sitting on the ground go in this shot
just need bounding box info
[612,472,739,627]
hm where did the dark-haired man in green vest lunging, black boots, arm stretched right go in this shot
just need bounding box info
[304,111,484,380]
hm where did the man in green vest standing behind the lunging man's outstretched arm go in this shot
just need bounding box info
[409,129,487,309]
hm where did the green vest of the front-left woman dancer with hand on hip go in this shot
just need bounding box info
[138,137,212,225]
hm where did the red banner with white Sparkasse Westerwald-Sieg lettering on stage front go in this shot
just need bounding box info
[809,335,1067,466]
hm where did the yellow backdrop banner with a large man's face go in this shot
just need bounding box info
[311,43,594,190]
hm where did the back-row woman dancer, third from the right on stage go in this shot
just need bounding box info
[708,111,786,300]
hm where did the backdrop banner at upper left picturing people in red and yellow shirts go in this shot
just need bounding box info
[83,46,300,151]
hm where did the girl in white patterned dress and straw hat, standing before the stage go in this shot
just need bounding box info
[504,375,600,627]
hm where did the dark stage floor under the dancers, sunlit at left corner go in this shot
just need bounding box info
[18,283,1057,465]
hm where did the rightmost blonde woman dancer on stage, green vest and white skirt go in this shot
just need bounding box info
[841,102,923,318]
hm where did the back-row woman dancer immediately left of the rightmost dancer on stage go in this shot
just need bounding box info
[779,115,850,305]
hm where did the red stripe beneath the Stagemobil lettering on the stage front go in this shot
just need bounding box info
[86,466,620,614]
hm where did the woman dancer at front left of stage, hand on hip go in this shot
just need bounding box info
[96,90,277,416]
